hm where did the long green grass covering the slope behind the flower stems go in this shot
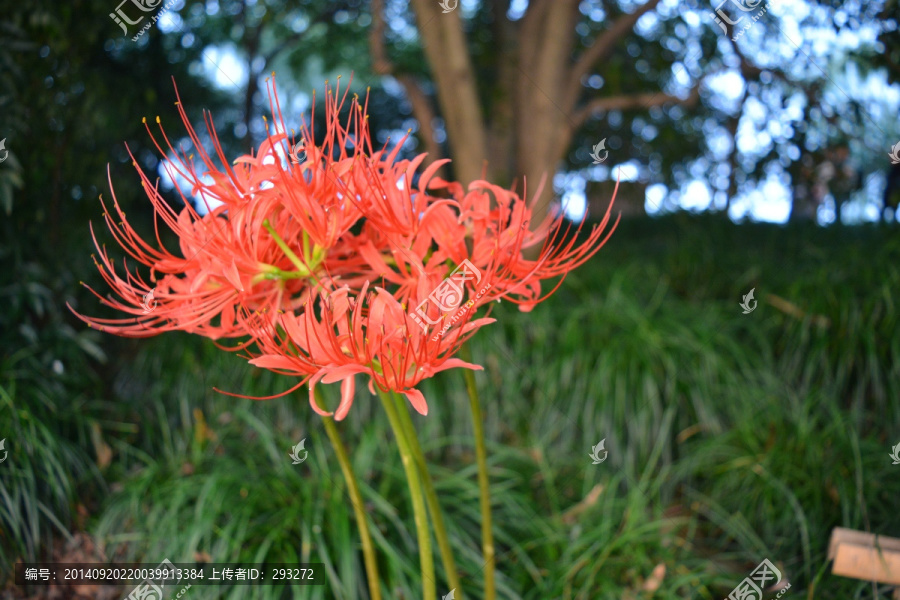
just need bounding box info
[0,214,900,600]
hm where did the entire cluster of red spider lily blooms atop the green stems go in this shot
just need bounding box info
[70,78,614,420]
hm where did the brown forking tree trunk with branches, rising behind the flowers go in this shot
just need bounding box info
[396,0,699,236]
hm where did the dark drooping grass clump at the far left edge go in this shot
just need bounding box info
[0,244,116,581]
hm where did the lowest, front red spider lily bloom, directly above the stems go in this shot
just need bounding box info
[231,283,494,421]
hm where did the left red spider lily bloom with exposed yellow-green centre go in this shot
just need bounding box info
[67,74,382,339]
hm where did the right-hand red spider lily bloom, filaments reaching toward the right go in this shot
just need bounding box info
[348,173,618,331]
